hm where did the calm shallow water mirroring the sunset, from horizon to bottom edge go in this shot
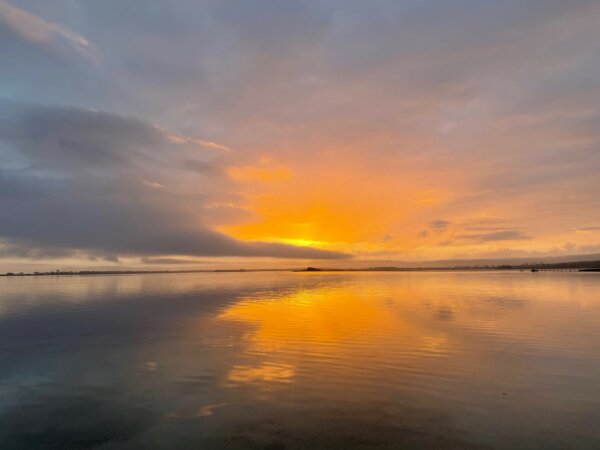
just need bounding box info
[0,272,600,450]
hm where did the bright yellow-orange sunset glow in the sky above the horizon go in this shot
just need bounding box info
[220,156,462,251]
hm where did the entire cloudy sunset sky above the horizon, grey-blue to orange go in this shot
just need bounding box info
[0,0,600,271]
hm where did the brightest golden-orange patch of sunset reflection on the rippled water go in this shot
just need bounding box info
[220,284,418,394]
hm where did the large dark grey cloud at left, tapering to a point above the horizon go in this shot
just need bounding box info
[0,101,348,259]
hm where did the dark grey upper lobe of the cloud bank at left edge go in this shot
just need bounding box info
[0,101,162,175]
